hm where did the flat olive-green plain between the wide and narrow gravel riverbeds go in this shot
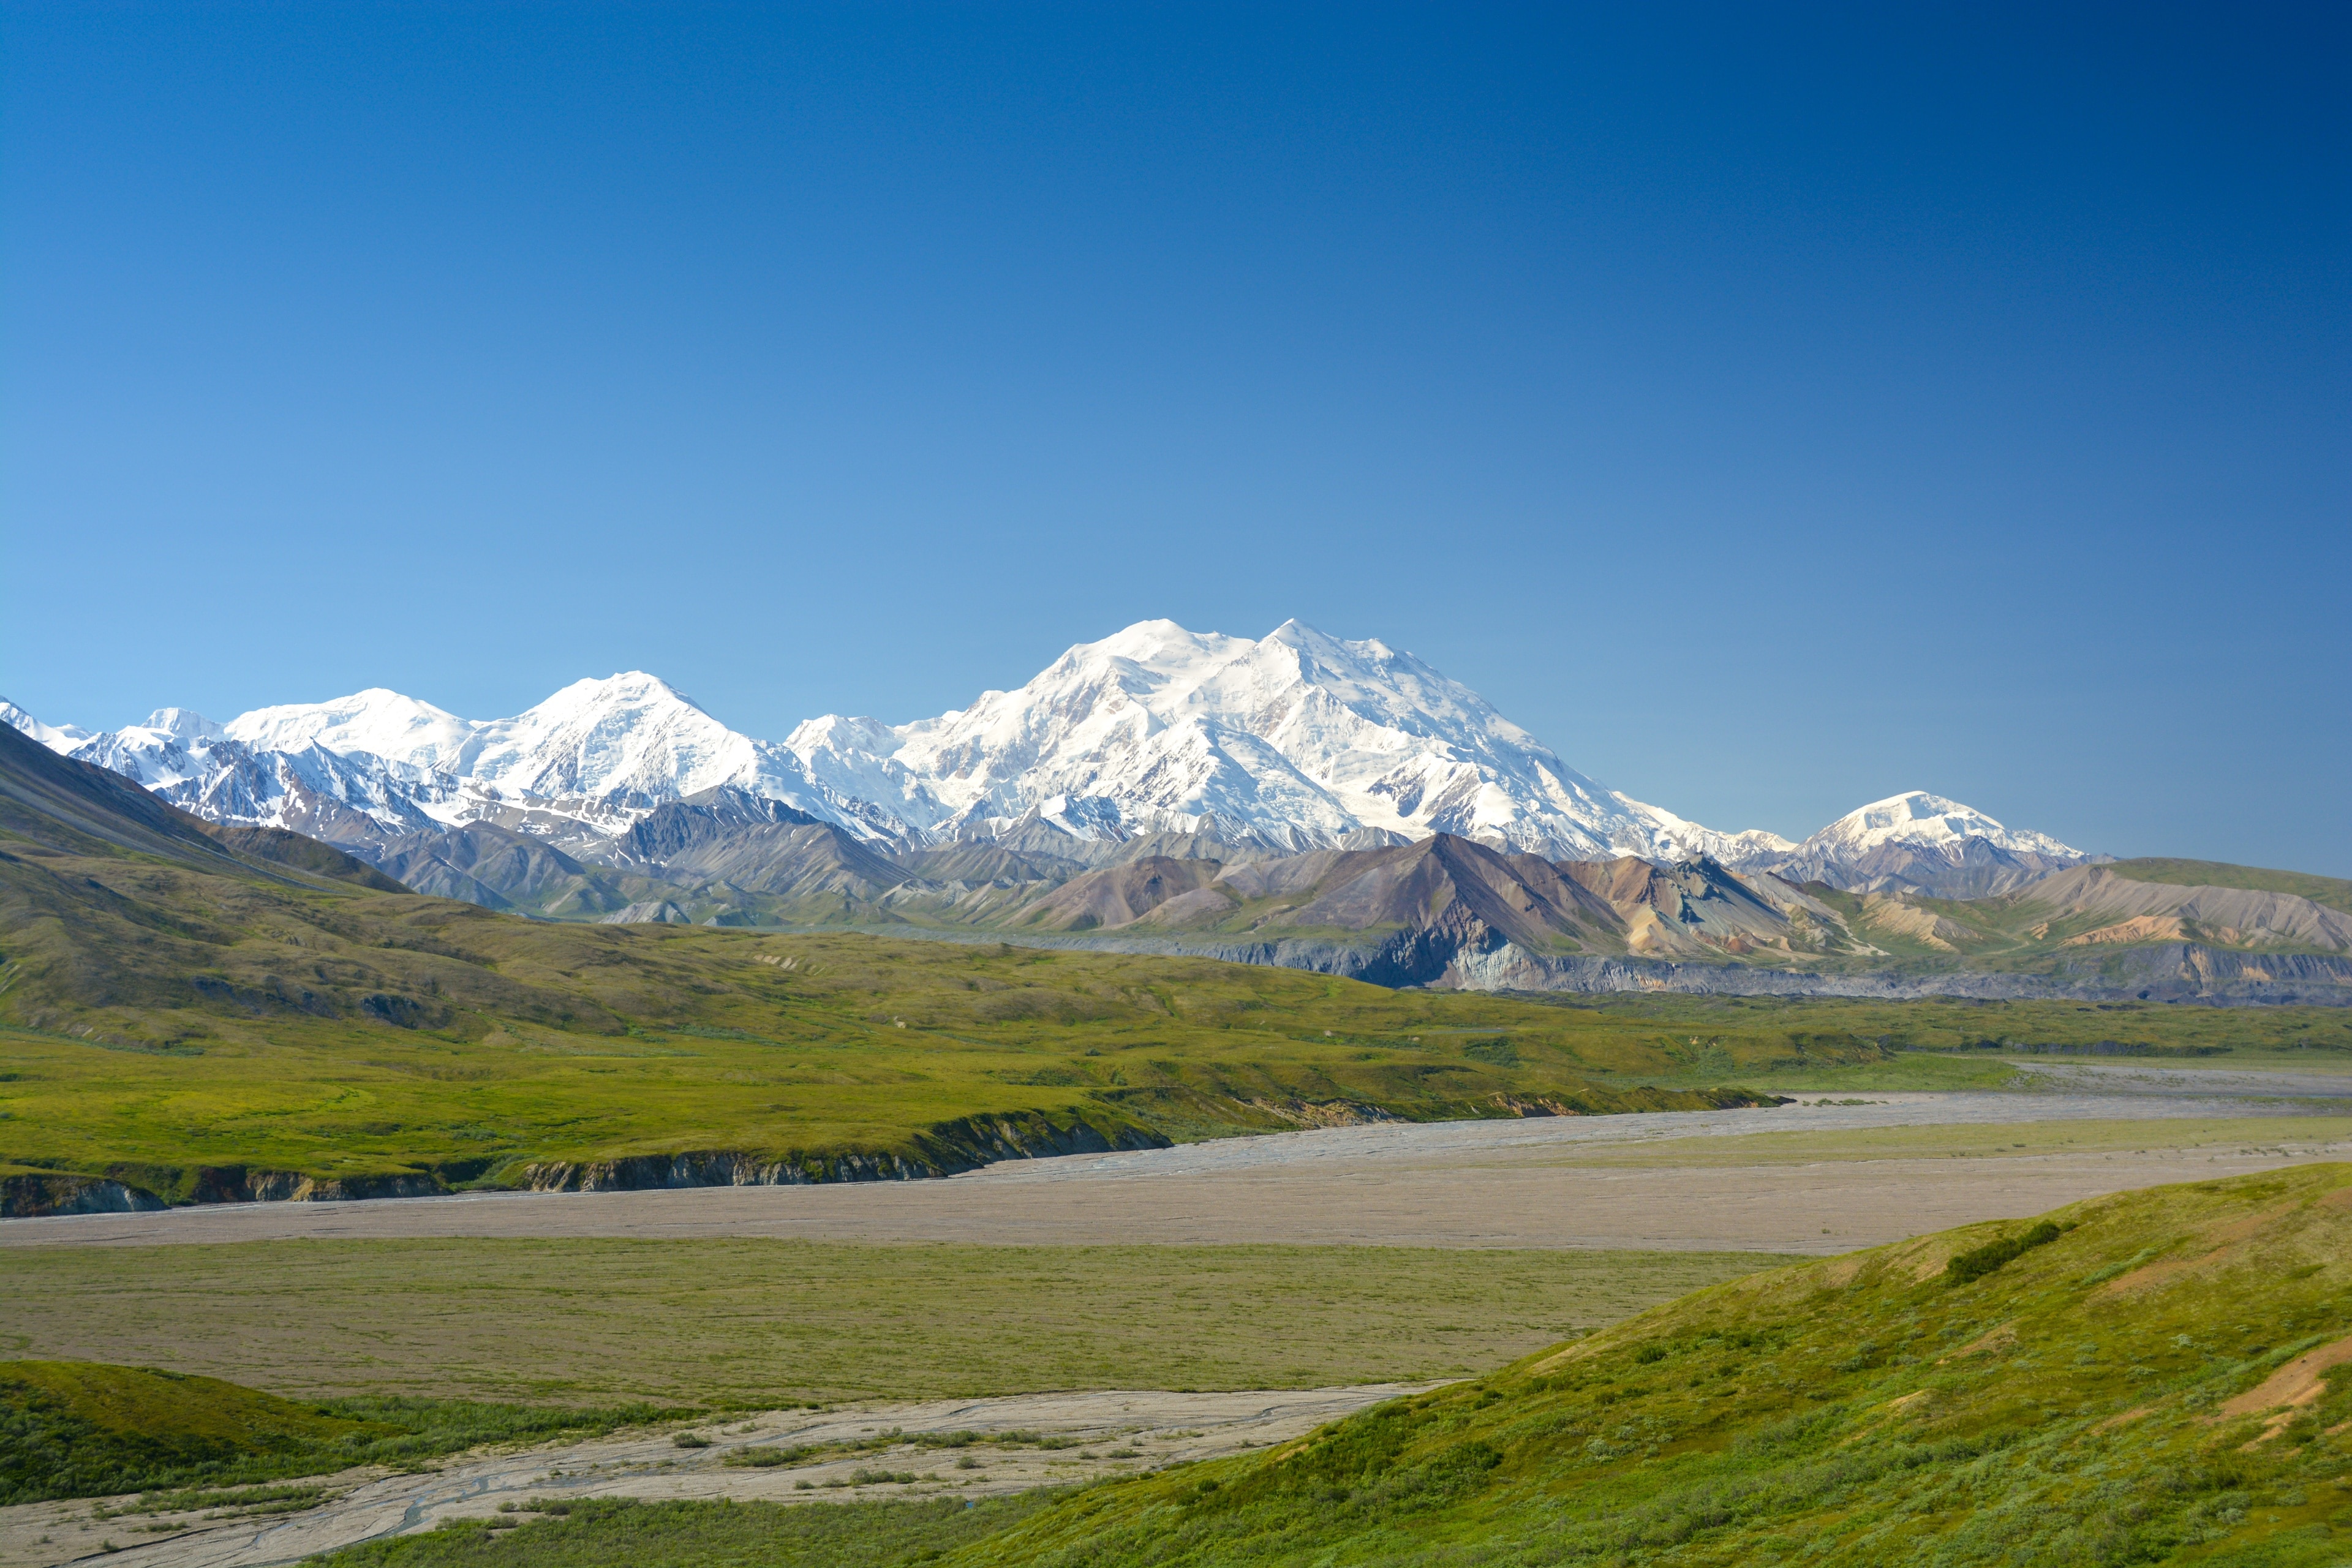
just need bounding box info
[0,1239,1778,1406]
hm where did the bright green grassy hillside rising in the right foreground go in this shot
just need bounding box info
[948,1166,2352,1568]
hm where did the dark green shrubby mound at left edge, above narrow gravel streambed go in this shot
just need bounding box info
[0,1361,689,1507]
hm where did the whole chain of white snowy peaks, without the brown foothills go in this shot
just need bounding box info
[0,620,2084,891]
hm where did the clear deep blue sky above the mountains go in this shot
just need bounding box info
[0,2,2352,875]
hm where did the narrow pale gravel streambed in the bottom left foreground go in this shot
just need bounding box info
[0,1382,1434,1568]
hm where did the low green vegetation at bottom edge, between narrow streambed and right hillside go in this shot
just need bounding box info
[311,1490,1061,1568]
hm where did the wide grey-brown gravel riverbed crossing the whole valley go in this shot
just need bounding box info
[13,1074,2352,1251]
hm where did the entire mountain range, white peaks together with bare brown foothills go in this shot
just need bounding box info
[13,620,2352,995]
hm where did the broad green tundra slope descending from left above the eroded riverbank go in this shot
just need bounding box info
[0,780,1877,1197]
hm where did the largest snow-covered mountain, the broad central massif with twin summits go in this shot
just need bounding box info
[786,620,1722,858]
